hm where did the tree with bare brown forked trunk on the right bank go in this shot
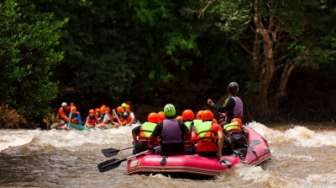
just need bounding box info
[198,0,333,115]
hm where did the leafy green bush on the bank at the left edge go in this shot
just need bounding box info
[0,0,65,120]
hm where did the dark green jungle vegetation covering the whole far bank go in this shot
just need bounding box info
[0,0,336,127]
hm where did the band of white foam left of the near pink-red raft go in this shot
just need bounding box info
[0,126,134,151]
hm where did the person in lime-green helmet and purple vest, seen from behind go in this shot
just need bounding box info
[153,104,188,165]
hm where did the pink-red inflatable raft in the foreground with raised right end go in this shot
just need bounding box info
[127,127,271,176]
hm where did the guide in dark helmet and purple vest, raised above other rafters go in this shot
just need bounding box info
[207,82,244,125]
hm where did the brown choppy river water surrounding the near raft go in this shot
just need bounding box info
[0,122,336,188]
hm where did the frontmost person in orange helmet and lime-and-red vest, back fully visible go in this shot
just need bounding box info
[192,110,224,157]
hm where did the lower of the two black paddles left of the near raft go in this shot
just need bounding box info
[97,146,160,172]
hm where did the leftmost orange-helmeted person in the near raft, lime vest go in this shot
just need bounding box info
[132,112,159,154]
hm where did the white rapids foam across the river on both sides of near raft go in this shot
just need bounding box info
[0,122,336,153]
